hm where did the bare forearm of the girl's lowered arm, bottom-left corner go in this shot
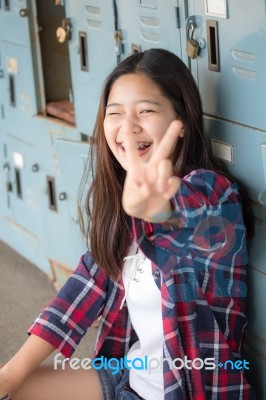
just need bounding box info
[0,335,55,395]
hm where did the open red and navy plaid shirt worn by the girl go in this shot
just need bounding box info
[29,170,253,400]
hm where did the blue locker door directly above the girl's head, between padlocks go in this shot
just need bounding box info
[116,0,182,57]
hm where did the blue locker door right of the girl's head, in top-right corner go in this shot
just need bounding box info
[189,0,266,130]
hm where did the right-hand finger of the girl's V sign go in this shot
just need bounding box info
[150,120,184,164]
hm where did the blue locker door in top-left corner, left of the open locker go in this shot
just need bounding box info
[0,0,37,126]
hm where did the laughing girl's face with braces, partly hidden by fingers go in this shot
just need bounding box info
[104,74,177,170]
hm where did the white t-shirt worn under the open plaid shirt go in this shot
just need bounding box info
[122,244,164,400]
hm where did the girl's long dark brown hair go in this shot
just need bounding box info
[79,49,254,278]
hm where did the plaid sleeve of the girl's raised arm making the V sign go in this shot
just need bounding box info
[133,170,248,272]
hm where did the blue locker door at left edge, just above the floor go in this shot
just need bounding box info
[0,129,49,272]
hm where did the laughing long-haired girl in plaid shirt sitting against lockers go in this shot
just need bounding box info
[0,49,254,400]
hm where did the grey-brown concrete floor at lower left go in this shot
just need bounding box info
[0,241,97,363]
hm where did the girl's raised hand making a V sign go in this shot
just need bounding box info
[122,120,184,222]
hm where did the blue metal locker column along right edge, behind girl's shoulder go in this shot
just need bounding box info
[187,0,266,399]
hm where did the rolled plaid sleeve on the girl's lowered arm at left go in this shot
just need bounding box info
[28,253,109,357]
